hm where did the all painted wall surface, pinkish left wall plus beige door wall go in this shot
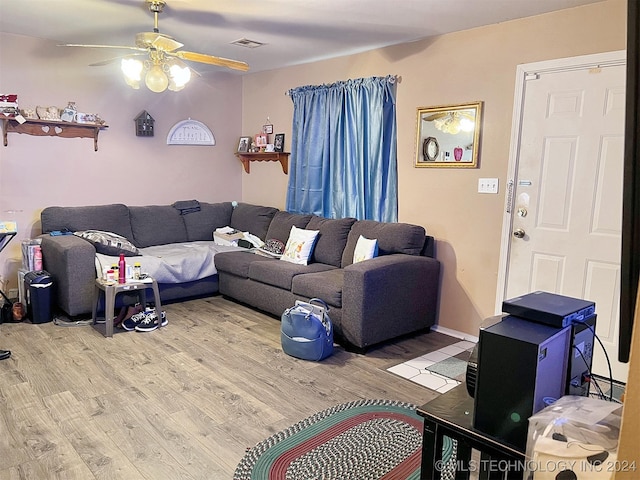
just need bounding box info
[0,0,626,335]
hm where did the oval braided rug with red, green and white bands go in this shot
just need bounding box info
[233,400,423,480]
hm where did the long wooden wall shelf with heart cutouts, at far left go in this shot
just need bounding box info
[1,118,109,152]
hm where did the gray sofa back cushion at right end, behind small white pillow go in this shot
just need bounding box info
[342,220,425,268]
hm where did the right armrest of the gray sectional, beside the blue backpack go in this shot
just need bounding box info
[341,254,440,348]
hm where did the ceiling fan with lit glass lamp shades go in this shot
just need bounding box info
[60,0,249,92]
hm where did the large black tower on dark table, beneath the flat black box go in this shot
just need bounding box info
[473,316,571,452]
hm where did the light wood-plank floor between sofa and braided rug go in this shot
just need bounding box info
[0,296,457,480]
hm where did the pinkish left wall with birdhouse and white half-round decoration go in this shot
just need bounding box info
[0,34,242,289]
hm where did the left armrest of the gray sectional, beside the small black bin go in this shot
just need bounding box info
[40,235,96,316]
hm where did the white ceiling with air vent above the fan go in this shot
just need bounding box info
[0,0,601,73]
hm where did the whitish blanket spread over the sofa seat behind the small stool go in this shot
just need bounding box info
[96,241,244,283]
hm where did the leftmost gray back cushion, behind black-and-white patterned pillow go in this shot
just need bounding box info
[40,203,133,240]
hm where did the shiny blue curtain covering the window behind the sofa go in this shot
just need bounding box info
[286,76,398,222]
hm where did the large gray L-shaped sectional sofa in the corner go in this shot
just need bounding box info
[41,201,440,350]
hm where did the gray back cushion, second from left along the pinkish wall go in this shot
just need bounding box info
[129,205,188,248]
